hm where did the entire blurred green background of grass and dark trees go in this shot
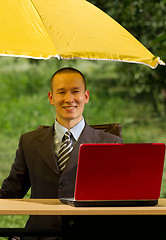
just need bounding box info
[0,0,166,236]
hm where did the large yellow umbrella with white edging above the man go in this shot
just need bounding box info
[0,0,164,68]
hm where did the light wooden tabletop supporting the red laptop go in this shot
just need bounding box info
[0,198,166,215]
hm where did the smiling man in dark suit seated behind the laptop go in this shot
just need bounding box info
[0,68,122,239]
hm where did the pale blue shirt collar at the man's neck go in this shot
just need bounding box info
[55,118,85,141]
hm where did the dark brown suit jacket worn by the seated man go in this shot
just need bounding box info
[0,124,122,235]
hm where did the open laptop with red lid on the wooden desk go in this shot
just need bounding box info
[60,143,165,206]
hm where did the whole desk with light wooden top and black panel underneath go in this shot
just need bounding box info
[0,199,166,240]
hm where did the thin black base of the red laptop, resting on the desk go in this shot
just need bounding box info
[59,198,158,207]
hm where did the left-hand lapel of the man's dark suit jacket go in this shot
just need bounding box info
[38,126,60,175]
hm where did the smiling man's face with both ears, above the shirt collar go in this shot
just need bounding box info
[48,72,89,129]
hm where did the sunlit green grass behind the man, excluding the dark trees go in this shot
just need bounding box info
[0,58,166,230]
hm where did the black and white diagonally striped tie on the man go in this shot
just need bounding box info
[58,131,73,172]
